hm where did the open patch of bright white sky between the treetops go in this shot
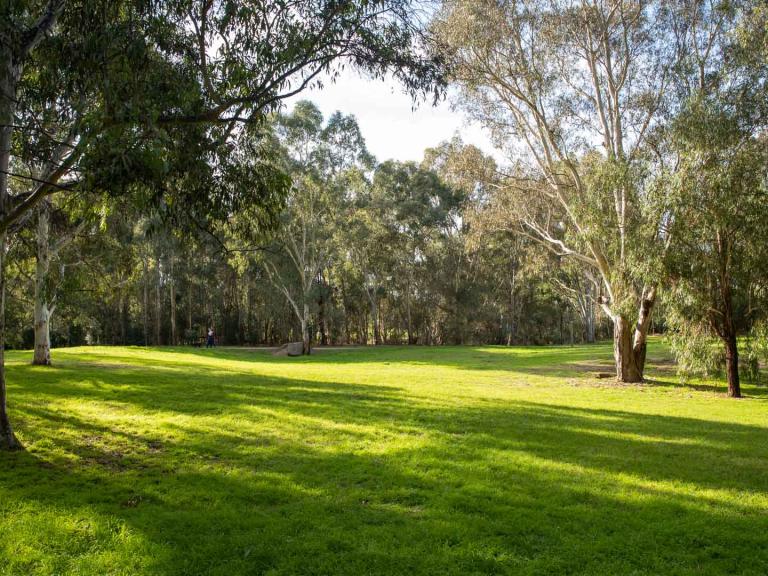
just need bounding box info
[288,72,497,162]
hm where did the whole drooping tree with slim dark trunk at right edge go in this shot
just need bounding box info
[661,0,768,397]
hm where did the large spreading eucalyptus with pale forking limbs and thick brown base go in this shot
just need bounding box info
[434,0,674,382]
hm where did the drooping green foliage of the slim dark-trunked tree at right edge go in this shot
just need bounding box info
[663,13,768,390]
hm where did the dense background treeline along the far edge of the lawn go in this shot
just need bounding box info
[3,102,607,348]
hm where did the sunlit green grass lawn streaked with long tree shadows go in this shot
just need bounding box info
[0,342,768,576]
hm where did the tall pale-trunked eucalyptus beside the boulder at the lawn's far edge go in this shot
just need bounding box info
[263,101,373,354]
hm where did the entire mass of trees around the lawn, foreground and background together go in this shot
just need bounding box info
[0,0,768,445]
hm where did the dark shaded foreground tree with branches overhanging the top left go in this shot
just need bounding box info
[0,0,441,447]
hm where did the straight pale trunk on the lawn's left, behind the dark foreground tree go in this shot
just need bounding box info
[32,201,52,366]
